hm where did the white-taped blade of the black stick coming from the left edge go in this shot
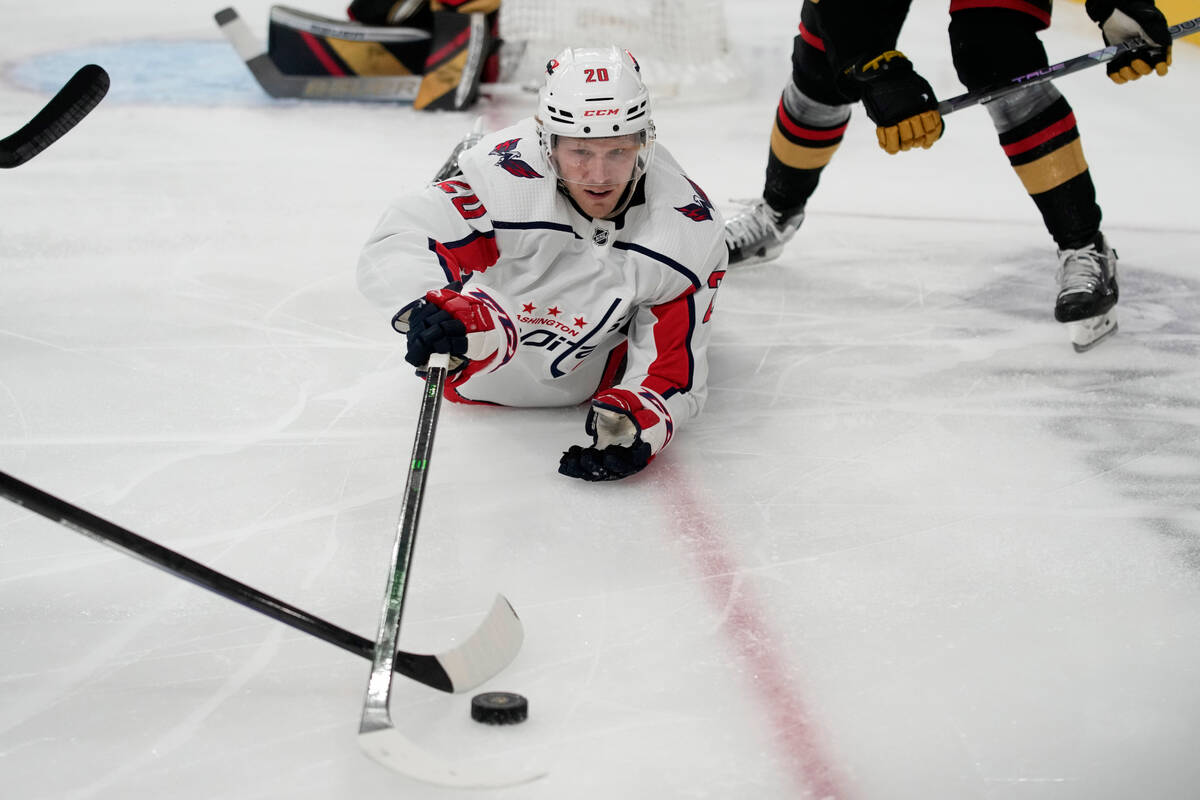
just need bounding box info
[394,595,524,693]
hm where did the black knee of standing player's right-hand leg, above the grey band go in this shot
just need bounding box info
[949,8,1049,90]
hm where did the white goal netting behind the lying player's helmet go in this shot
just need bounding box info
[500,0,744,100]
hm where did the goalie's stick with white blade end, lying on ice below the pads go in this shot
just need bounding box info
[214,8,421,103]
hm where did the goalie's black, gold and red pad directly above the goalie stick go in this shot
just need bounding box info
[266,6,432,76]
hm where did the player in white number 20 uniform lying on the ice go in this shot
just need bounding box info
[358,48,727,481]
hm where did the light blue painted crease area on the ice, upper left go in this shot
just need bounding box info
[4,40,278,106]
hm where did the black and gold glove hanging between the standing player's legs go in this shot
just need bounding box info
[845,50,943,154]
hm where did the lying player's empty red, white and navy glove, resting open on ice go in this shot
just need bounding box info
[558,389,659,481]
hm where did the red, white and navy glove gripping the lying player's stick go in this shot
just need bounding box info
[391,284,505,372]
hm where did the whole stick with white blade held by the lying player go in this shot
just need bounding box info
[359,354,541,788]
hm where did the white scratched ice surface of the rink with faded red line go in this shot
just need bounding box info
[0,0,1200,800]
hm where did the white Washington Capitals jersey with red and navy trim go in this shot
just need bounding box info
[358,119,727,452]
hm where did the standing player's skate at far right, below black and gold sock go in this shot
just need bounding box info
[1054,234,1117,353]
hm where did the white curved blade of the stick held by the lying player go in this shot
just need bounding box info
[359,715,546,789]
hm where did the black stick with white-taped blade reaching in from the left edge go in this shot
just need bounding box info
[0,473,524,692]
